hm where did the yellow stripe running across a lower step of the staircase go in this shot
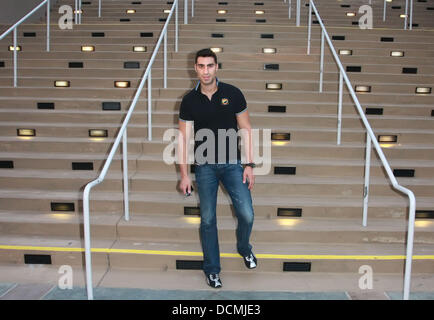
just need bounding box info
[0,245,434,260]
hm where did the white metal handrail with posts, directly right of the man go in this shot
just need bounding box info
[307,0,416,300]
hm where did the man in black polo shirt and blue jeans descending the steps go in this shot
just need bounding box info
[179,49,257,288]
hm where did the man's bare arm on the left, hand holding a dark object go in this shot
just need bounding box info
[178,120,192,194]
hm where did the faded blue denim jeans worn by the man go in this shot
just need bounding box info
[195,163,254,275]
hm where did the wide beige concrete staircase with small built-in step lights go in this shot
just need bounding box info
[0,0,434,300]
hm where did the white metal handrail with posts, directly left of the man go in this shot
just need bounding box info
[83,0,178,300]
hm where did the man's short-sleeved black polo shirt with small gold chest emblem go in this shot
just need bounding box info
[179,80,247,164]
